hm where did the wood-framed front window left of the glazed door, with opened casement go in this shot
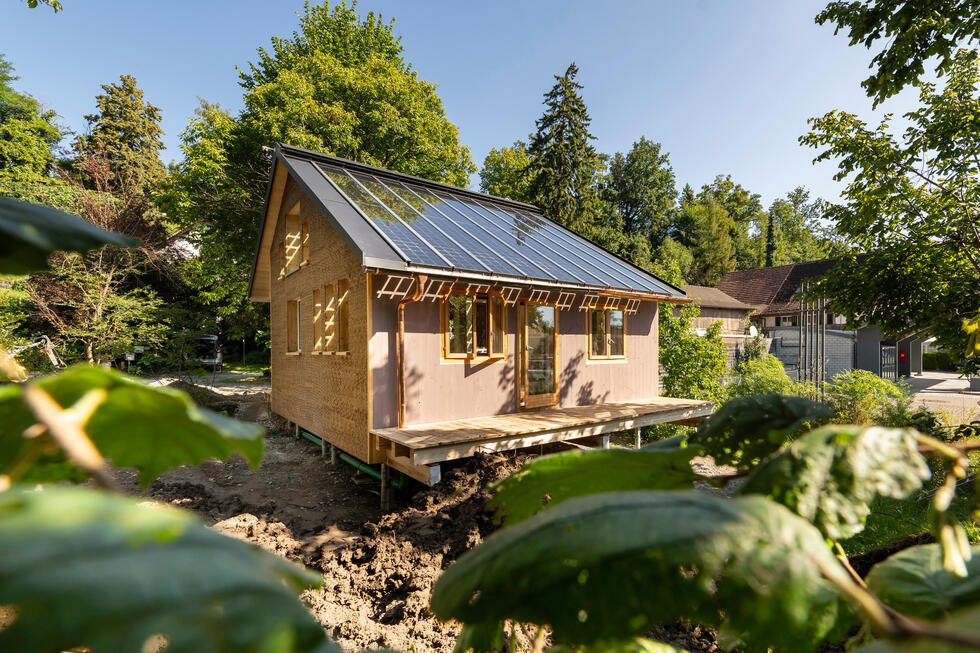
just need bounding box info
[442,294,507,359]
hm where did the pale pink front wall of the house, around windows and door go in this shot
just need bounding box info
[370,298,659,428]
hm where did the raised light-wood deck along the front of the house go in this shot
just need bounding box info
[371,397,715,485]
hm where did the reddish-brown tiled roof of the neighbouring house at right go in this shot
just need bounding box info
[718,259,837,316]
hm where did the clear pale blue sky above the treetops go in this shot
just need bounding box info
[0,0,914,205]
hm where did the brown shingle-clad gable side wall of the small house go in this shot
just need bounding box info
[270,179,377,462]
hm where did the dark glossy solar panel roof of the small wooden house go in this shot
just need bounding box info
[266,145,685,298]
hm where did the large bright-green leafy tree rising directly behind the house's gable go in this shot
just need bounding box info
[164,2,476,337]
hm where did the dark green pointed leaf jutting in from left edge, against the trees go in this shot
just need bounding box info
[0,197,139,274]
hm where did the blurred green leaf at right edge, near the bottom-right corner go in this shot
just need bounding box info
[866,544,980,620]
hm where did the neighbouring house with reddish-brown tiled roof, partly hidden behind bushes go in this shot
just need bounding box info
[718,259,925,379]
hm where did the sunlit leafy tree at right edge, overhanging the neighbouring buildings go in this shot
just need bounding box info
[801,50,980,360]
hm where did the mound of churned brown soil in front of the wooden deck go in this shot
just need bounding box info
[304,455,527,651]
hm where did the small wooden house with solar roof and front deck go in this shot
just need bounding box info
[250,145,712,485]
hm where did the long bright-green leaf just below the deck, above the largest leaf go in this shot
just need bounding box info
[488,447,702,526]
